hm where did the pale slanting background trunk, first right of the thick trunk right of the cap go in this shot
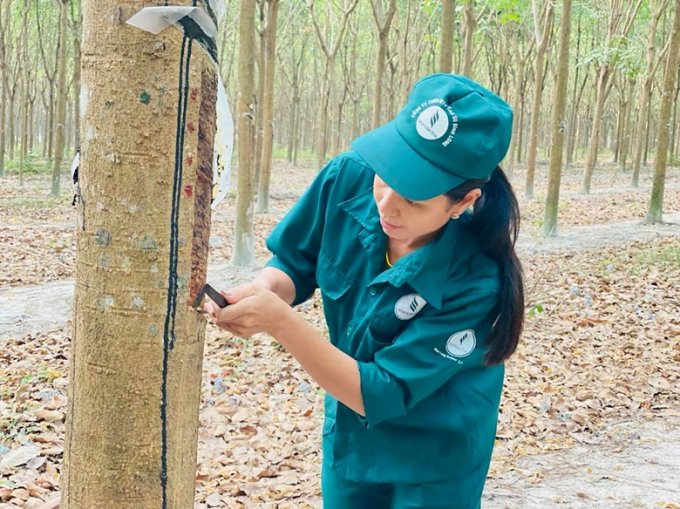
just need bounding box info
[581,0,643,194]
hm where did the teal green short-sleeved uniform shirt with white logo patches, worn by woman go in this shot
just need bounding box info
[267,152,504,484]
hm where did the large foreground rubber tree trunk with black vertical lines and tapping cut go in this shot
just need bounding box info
[61,0,217,509]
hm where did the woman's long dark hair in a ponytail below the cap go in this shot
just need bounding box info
[446,166,524,365]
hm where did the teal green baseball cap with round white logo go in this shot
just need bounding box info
[352,74,512,200]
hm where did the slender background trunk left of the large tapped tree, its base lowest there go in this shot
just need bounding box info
[50,0,69,196]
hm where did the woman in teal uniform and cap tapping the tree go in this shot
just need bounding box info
[206,74,524,509]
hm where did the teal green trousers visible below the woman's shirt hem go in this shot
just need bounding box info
[321,462,484,509]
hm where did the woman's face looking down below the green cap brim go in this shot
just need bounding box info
[373,174,480,244]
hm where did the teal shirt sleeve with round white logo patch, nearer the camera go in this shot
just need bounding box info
[358,292,498,428]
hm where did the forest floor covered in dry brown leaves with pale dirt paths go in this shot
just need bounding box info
[0,157,680,509]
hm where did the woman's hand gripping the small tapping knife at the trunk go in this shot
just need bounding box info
[205,283,294,338]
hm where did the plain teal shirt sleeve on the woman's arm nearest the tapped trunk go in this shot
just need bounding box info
[265,160,338,306]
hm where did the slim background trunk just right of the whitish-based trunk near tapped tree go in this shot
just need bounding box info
[257,0,279,212]
